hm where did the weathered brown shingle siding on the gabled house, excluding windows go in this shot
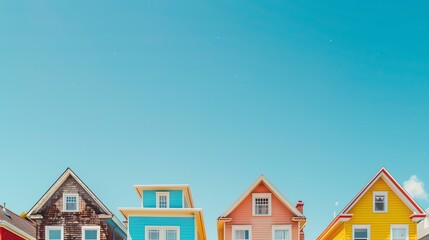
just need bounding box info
[33,176,119,240]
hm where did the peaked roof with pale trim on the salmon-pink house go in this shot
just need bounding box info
[219,175,304,218]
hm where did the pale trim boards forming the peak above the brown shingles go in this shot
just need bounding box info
[28,168,113,216]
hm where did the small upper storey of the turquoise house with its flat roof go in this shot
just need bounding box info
[134,184,194,208]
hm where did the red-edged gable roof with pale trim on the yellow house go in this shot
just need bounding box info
[317,167,426,239]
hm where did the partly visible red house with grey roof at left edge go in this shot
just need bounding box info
[0,205,36,240]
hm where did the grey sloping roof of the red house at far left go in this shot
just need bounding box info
[0,205,36,240]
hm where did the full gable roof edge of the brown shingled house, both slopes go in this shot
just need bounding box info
[27,168,127,233]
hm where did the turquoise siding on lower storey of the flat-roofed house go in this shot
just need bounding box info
[128,216,195,240]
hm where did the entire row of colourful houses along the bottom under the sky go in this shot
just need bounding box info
[0,168,429,240]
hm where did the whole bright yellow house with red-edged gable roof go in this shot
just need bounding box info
[317,168,426,240]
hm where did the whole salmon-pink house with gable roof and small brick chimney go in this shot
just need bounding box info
[217,176,307,240]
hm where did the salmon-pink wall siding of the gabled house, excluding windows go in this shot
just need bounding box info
[225,182,298,240]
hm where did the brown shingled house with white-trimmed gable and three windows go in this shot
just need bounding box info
[27,168,126,240]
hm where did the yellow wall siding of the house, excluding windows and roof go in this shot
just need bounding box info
[344,178,417,240]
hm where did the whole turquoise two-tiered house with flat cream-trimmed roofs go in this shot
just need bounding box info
[119,185,206,240]
